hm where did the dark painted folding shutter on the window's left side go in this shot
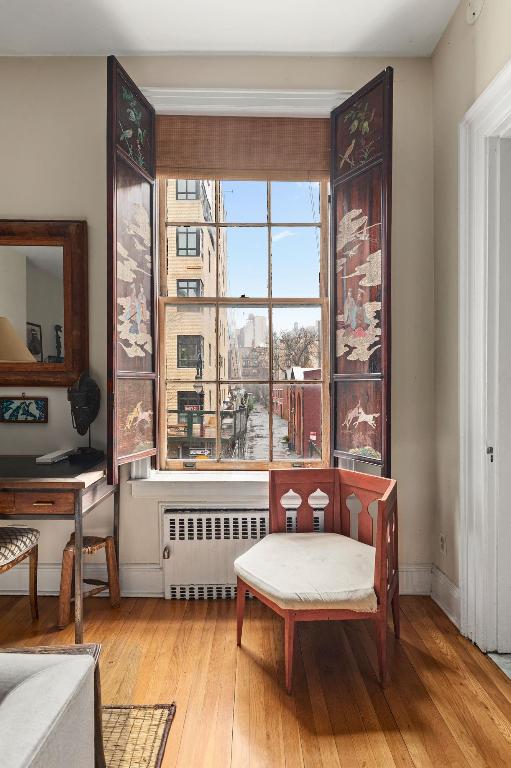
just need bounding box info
[107,56,158,483]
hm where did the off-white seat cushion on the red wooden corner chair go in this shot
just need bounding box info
[234,533,377,612]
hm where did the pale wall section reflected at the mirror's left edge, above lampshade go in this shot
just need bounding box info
[0,246,27,343]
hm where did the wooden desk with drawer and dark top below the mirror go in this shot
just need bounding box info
[0,456,119,643]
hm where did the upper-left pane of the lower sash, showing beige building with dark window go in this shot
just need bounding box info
[165,304,216,381]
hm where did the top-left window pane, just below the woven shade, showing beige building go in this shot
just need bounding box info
[166,179,215,224]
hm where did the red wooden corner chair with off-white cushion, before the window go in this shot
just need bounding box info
[234,469,399,693]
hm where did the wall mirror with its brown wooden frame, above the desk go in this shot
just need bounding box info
[0,219,88,386]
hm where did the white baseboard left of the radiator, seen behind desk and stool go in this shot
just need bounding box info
[0,563,164,597]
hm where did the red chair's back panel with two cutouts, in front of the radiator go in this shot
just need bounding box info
[270,469,339,533]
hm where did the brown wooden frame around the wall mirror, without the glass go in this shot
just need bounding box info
[0,219,89,387]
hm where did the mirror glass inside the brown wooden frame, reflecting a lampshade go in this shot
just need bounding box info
[0,245,64,365]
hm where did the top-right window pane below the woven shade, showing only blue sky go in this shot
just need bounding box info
[271,181,320,224]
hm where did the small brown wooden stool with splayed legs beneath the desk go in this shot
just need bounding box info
[58,533,121,629]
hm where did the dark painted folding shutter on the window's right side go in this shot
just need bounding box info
[331,67,393,476]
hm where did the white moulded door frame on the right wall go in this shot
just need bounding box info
[458,61,511,651]
